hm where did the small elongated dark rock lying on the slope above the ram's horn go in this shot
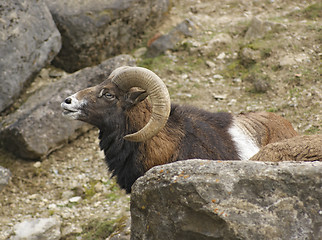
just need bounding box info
[147,19,195,57]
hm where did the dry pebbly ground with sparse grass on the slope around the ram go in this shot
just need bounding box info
[0,0,322,239]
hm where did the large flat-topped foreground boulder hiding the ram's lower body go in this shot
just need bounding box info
[131,160,322,240]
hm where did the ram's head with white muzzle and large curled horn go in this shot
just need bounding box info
[61,66,170,142]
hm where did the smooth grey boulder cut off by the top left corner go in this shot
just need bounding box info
[0,0,61,112]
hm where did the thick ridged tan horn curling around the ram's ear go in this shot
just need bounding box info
[111,67,171,142]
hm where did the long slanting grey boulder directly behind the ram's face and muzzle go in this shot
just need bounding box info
[0,55,134,159]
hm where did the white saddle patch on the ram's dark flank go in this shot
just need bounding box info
[228,123,259,160]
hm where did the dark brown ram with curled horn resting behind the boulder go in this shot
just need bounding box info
[61,67,297,192]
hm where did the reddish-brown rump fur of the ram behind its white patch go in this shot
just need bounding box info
[236,112,298,147]
